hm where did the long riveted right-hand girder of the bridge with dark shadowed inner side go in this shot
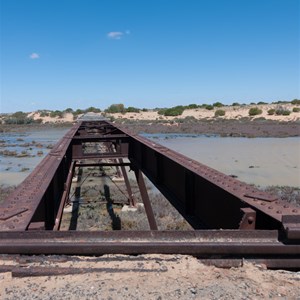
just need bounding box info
[113,123,300,229]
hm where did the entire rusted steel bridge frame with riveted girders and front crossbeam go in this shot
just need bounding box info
[0,121,300,268]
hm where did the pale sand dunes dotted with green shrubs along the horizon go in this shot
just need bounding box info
[21,104,300,123]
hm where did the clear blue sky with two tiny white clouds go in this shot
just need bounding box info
[0,0,300,112]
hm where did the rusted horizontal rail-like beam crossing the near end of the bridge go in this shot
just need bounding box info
[0,230,300,258]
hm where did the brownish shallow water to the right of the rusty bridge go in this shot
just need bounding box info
[147,135,300,187]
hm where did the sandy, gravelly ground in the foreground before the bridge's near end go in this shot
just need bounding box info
[0,254,300,300]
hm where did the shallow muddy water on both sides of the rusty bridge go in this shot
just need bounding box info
[0,129,300,187]
